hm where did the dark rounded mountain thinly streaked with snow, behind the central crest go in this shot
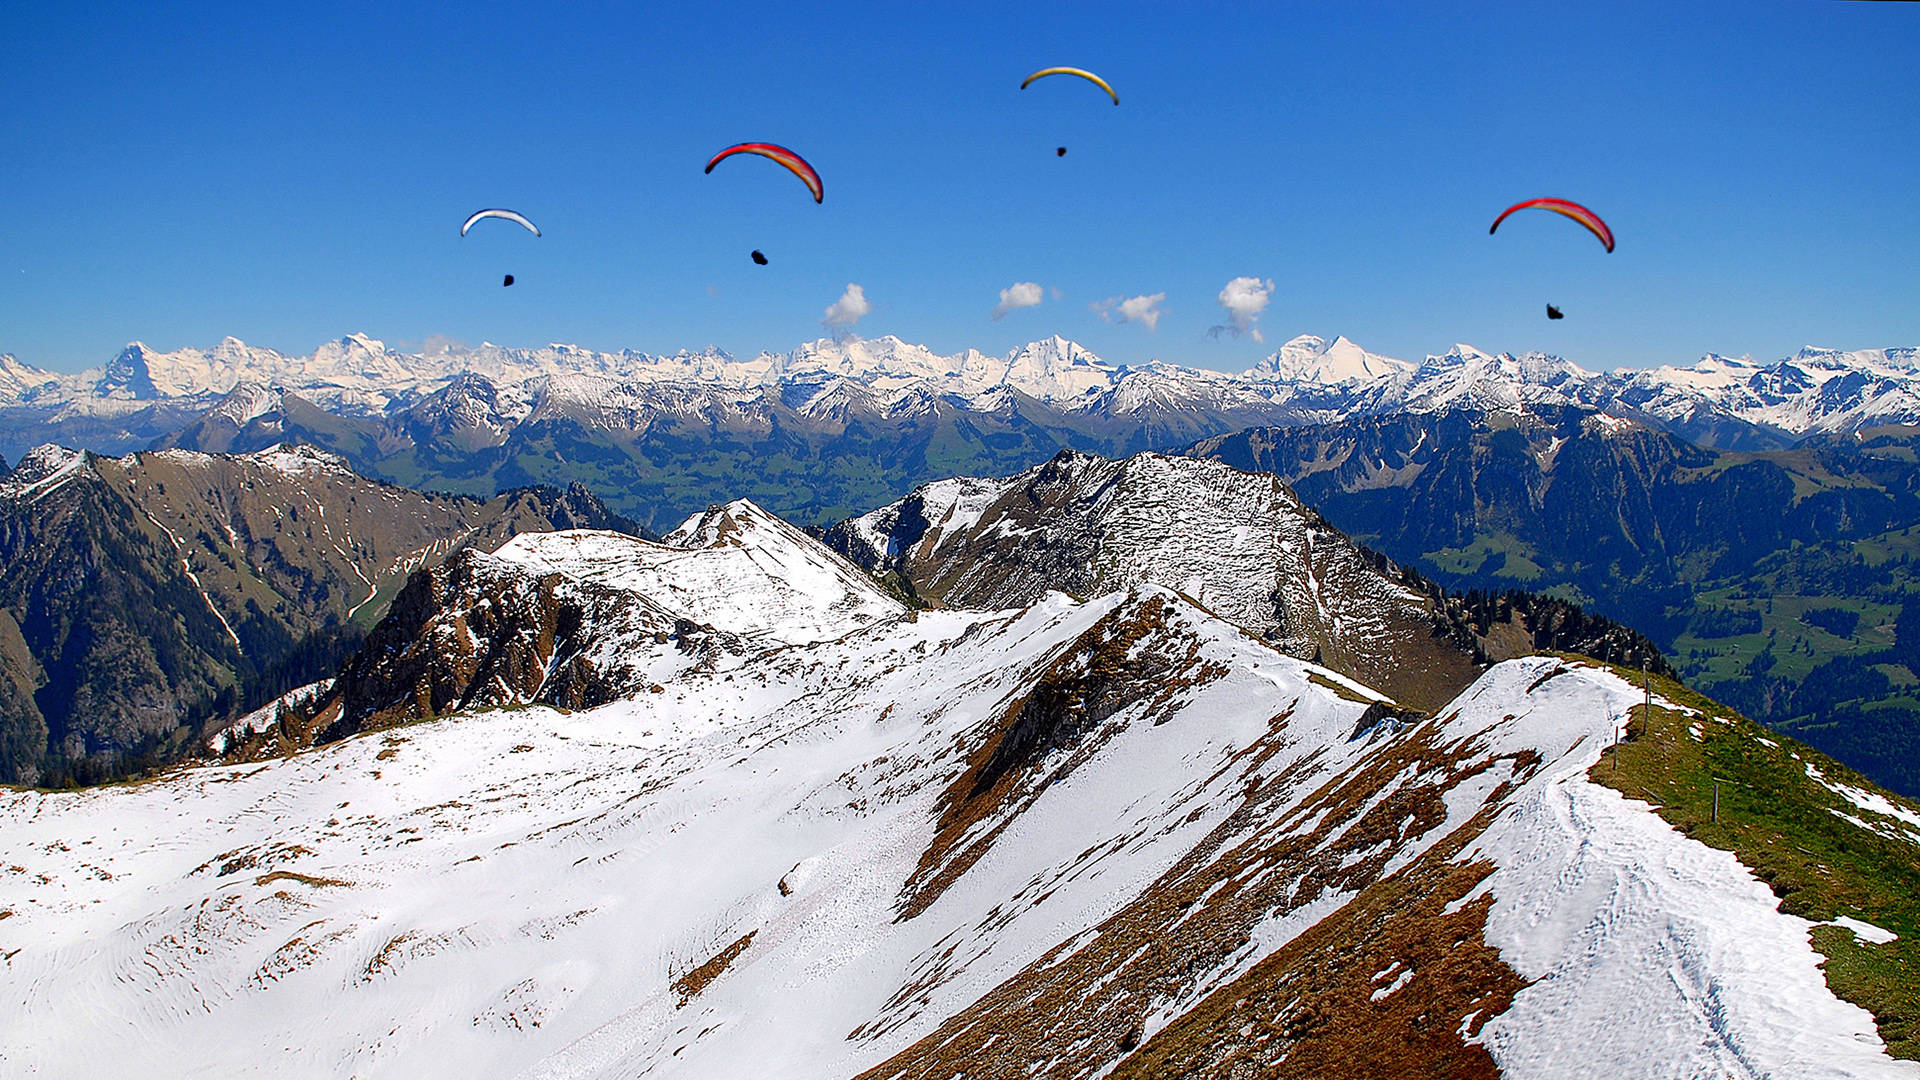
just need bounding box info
[828,445,1505,707]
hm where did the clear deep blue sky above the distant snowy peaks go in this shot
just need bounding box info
[0,0,1920,371]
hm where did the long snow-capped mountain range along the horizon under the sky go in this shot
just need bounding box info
[0,334,1920,442]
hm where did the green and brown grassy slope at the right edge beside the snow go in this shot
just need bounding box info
[1569,657,1920,1059]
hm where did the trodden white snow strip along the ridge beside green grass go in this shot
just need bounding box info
[1461,659,1920,1080]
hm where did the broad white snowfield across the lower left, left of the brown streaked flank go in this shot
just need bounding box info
[0,596,1382,1078]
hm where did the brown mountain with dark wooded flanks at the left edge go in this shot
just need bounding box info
[0,446,632,782]
